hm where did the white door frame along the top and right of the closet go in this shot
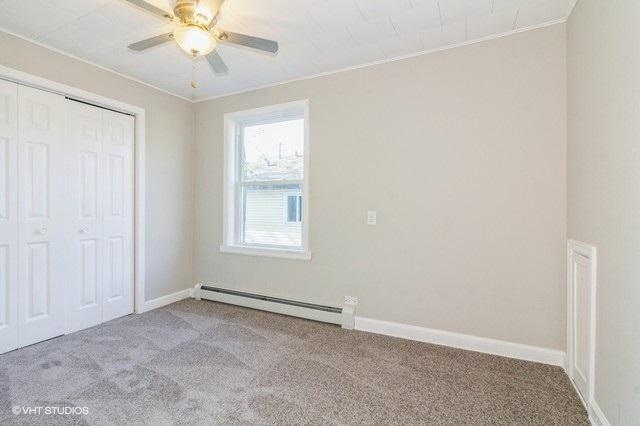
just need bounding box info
[0,65,146,314]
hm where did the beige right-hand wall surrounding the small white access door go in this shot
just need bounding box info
[567,0,640,425]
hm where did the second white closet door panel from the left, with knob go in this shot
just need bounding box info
[18,86,68,346]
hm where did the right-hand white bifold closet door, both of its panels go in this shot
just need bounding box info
[67,101,134,332]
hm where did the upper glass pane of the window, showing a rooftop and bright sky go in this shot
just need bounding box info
[242,119,304,181]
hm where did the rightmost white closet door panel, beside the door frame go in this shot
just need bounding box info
[103,111,134,321]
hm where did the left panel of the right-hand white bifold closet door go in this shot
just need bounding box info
[67,100,103,332]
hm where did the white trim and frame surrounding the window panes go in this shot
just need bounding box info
[220,100,311,260]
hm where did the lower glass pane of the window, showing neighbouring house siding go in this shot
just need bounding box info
[242,185,302,247]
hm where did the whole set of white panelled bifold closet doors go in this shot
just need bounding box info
[0,80,134,353]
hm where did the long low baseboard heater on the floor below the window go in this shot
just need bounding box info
[193,284,354,329]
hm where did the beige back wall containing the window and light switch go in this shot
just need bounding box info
[194,25,566,349]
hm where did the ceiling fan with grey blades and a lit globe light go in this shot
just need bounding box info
[126,0,278,74]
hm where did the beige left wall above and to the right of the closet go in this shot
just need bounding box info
[0,32,194,300]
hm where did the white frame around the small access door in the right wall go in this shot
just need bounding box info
[567,240,598,410]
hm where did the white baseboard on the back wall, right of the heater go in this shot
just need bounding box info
[355,317,565,367]
